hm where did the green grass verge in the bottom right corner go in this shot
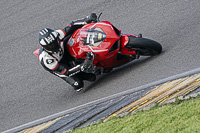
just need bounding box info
[68,98,200,133]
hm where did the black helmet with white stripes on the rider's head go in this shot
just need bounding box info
[38,28,60,53]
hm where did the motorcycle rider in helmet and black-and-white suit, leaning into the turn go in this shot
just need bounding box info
[38,13,97,91]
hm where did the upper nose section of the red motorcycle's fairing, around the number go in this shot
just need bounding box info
[68,21,120,58]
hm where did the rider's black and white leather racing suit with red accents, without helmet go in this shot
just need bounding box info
[39,17,96,90]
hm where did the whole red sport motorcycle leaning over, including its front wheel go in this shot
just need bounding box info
[67,16,162,73]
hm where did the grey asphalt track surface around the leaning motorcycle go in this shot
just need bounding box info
[0,0,200,132]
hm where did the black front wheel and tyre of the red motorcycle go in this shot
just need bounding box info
[126,36,162,56]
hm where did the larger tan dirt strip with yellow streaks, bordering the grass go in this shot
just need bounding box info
[104,74,200,122]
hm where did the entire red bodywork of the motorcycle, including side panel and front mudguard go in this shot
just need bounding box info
[67,21,136,69]
